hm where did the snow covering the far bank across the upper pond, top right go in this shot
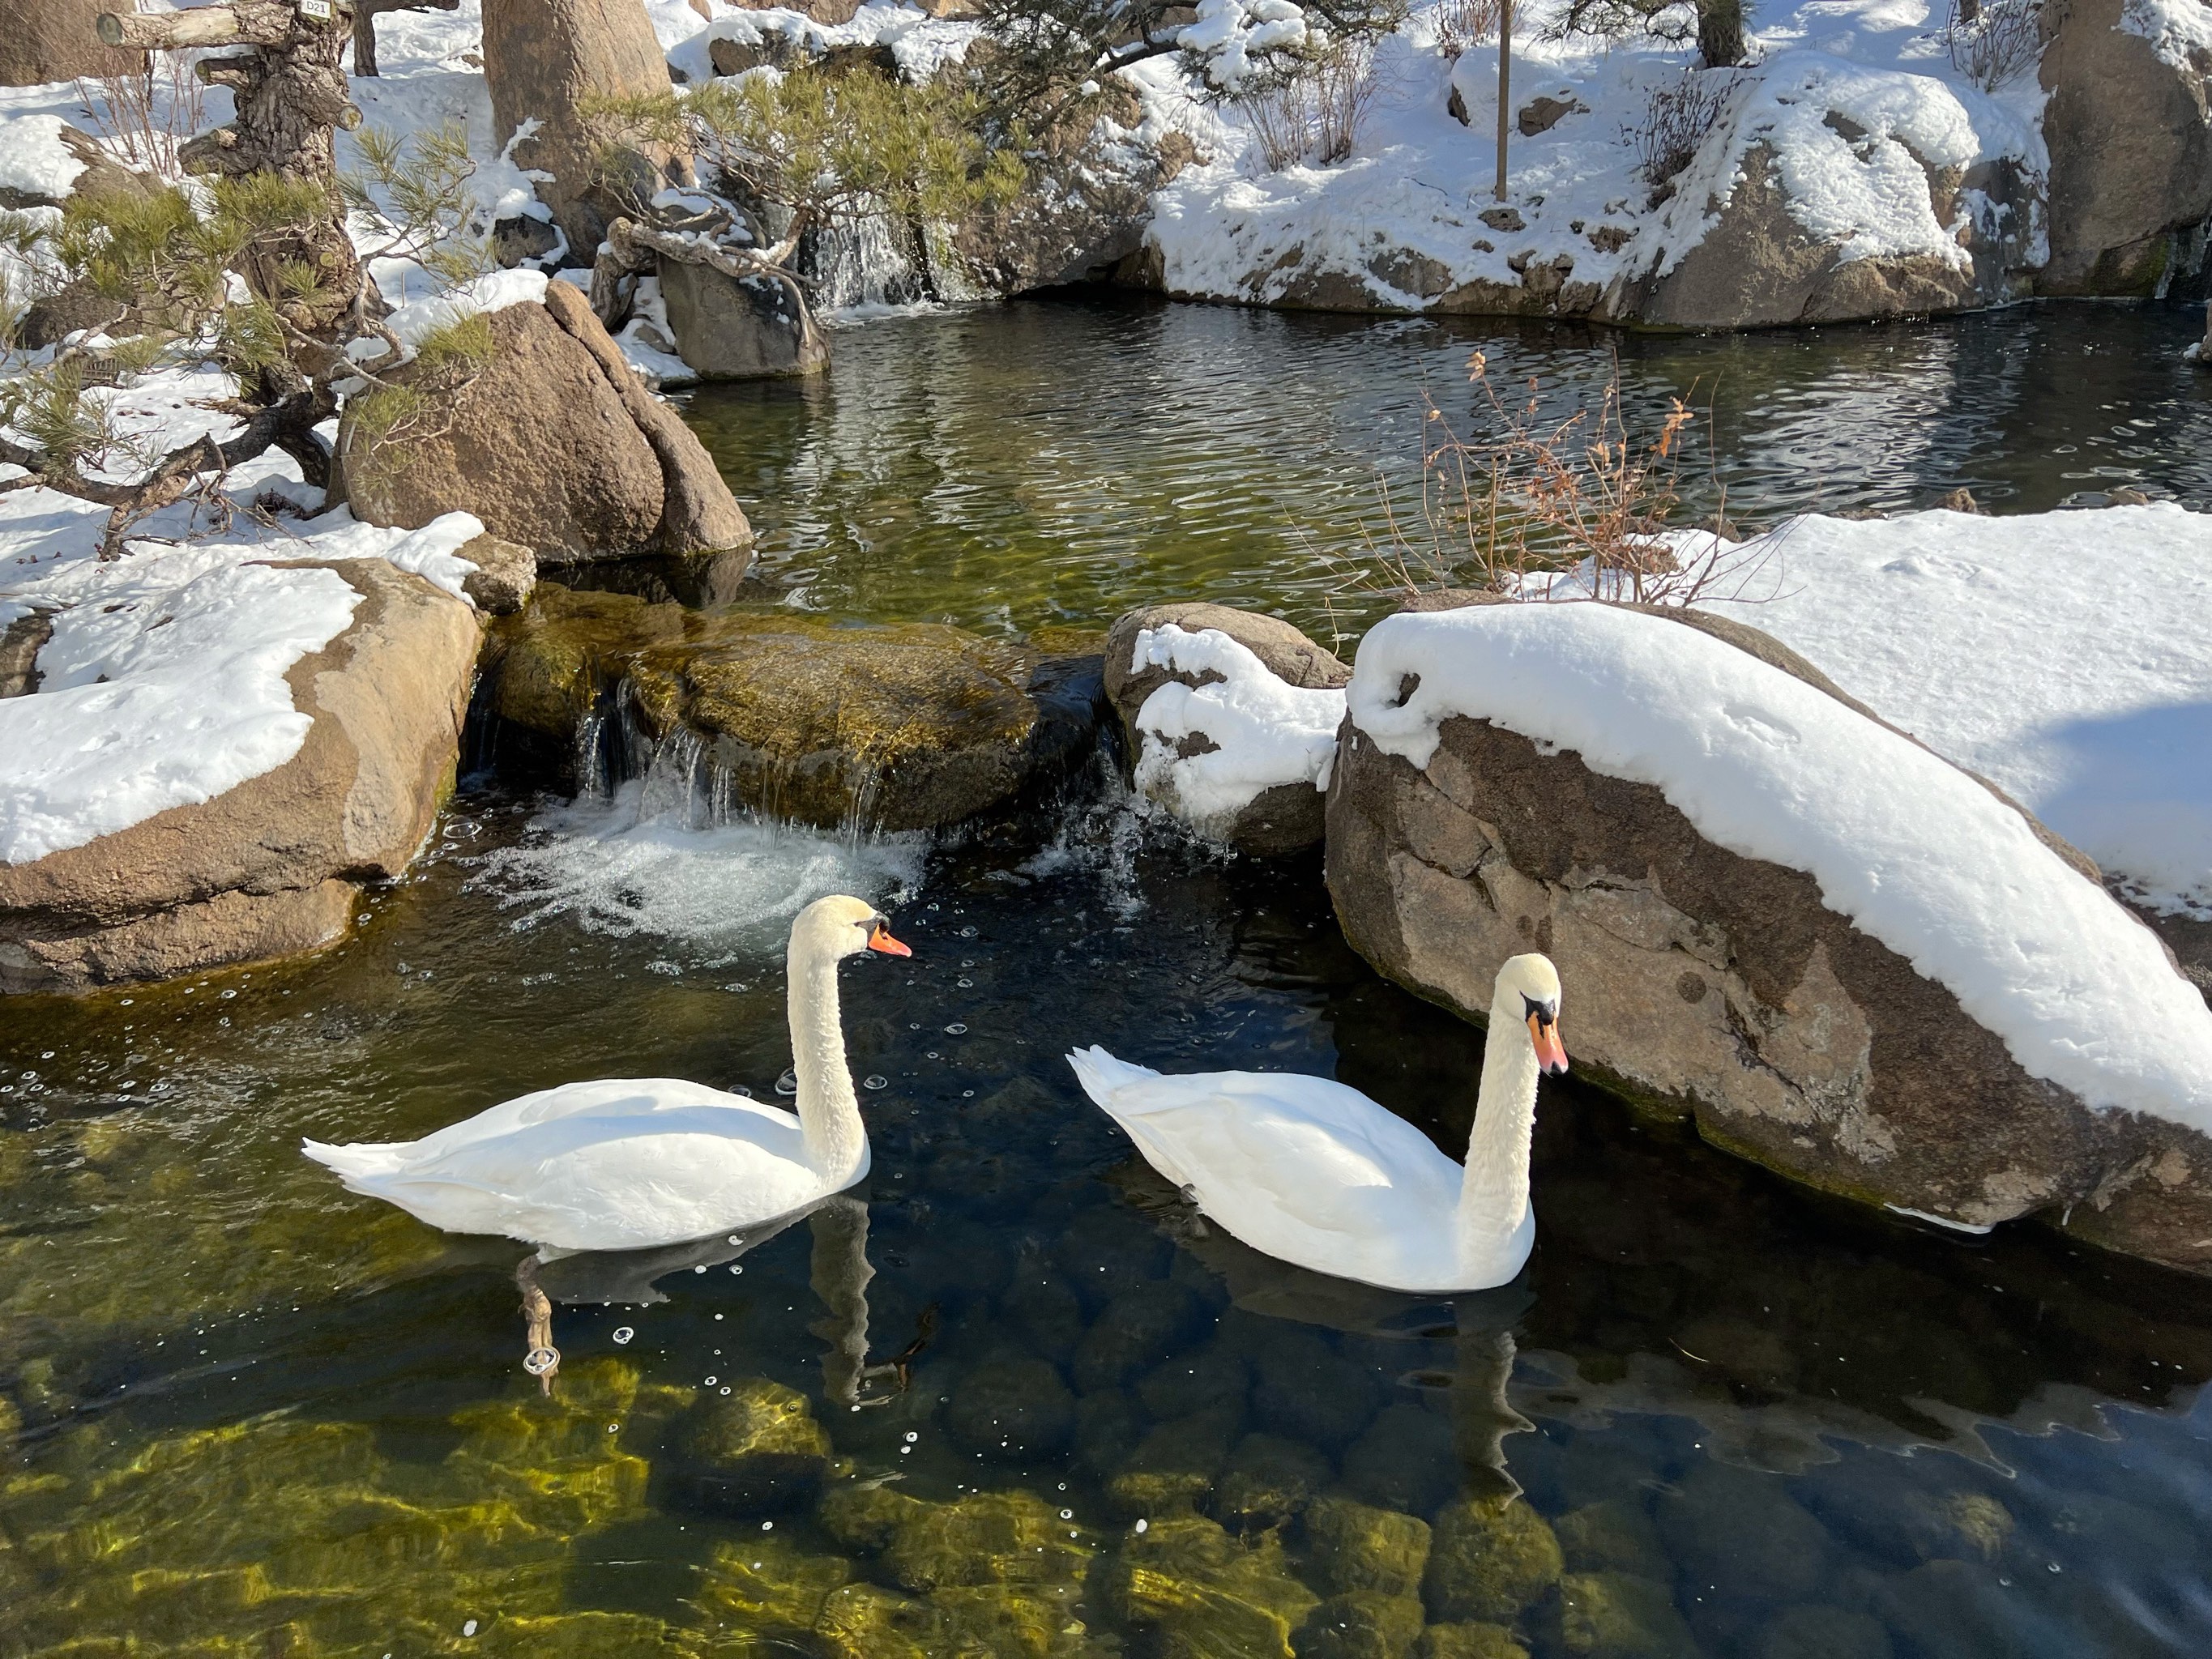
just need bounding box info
[1124,0,2043,309]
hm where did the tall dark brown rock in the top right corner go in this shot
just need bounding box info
[2037,0,2212,294]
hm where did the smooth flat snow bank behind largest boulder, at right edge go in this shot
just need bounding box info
[1712,502,2212,918]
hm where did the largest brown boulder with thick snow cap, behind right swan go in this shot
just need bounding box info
[1327,603,2212,1269]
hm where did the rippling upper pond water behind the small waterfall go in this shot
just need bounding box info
[685,301,2212,642]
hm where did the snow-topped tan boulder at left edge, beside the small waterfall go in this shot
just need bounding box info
[0,559,478,991]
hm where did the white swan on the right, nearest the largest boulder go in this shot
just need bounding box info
[1069,956,1566,1292]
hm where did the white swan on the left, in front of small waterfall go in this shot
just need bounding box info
[301,896,909,1256]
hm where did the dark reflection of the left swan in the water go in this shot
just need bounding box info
[515,1192,936,1407]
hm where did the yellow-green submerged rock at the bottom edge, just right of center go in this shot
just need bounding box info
[1106,1516,1318,1659]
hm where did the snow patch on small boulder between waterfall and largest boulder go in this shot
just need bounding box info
[1130,621,1345,834]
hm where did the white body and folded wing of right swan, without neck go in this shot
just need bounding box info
[1078,1051,1460,1287]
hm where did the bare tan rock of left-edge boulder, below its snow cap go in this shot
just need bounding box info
[0,560,478,991]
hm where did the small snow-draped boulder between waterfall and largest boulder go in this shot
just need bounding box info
[1106,602,1352,854]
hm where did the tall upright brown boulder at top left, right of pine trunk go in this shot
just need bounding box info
[485,0,690,266]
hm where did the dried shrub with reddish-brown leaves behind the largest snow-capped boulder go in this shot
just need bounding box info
[1367,352,1776,606]
